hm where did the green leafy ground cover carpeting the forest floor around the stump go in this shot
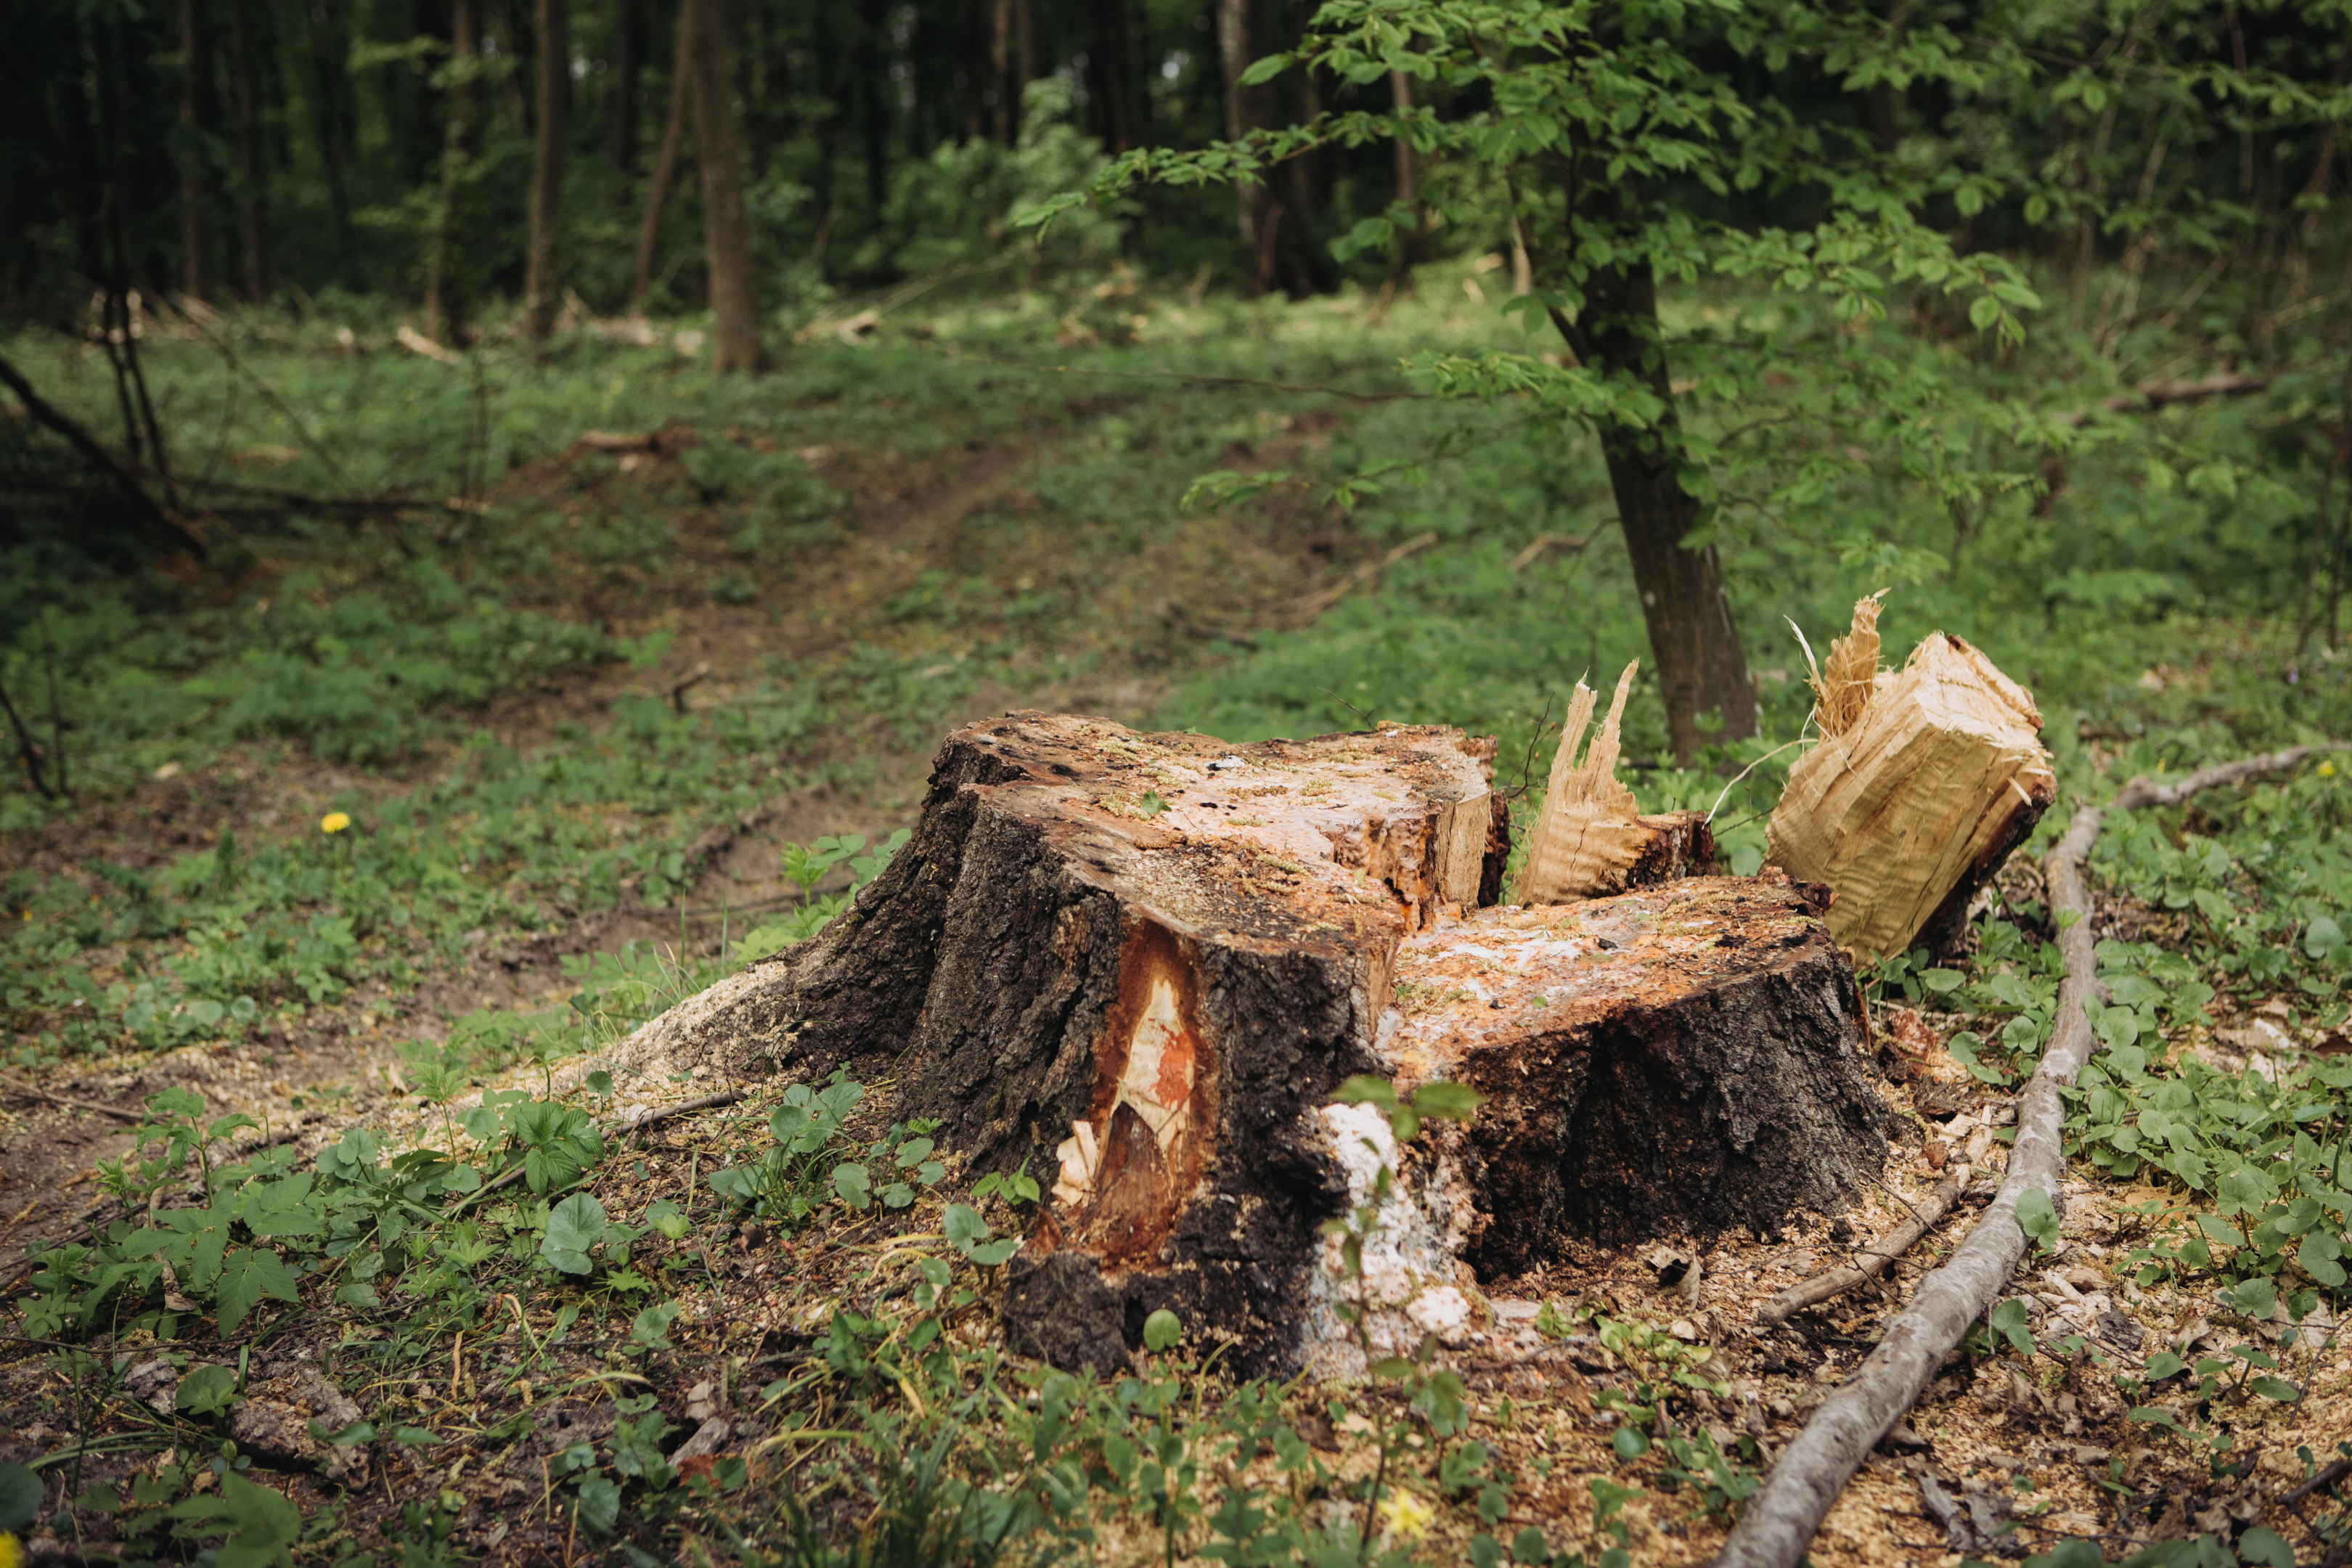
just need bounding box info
[0,251,2352,1568]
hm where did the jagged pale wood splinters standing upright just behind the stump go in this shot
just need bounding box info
[1515,661,1715,905]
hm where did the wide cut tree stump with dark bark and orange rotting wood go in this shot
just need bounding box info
[614,712,1886,1371]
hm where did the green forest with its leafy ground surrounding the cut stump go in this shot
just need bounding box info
[0,0,2352,1568]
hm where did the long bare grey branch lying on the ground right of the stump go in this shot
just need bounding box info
[1715,743,2348,1568]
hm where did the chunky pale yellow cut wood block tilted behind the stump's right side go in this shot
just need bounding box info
[1766,597,2058,961]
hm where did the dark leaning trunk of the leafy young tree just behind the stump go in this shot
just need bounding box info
[1552,171,1757,764]
